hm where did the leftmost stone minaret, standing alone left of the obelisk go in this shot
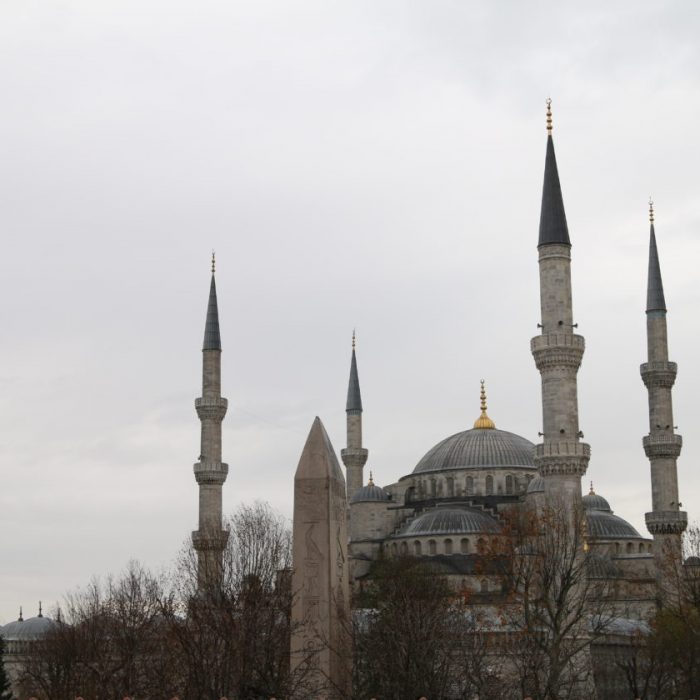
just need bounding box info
[192,253,228,593]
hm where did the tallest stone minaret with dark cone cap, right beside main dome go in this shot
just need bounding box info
[530,100,590,503]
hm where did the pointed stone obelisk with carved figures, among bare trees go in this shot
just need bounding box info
[291,418,351,700]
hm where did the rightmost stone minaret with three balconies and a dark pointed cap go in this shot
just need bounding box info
[640,200,688,557]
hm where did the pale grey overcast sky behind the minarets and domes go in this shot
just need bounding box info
[0,0,700,622]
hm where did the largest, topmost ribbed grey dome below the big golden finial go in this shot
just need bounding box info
[413,428,535,474]
